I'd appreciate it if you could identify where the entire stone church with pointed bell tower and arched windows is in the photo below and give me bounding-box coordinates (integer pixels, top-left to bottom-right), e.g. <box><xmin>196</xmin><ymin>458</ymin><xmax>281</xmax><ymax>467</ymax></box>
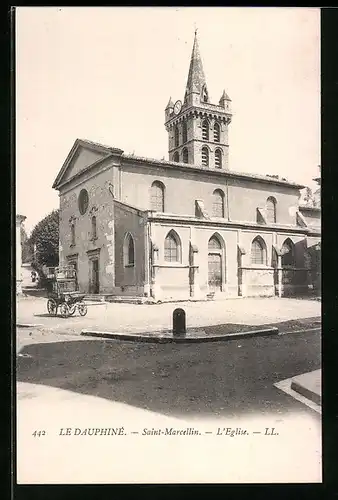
<box><xmin>53</xmin><ymin>35</ymin><xmax>320</xmax><ymax>301</ymax></box>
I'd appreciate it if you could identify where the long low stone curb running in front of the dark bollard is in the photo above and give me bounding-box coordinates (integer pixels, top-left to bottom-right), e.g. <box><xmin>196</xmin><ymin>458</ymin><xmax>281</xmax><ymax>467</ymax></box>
<box><xmin>81</xmin><ymin>327</ymin><xmax>278</xmax><ymax>344</ymax></box>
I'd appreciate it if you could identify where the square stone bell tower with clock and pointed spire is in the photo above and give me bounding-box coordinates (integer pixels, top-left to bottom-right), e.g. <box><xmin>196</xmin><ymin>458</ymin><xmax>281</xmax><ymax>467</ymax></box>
<box><xmin>165</xmin><ymin>30</ymin><xmax>232</xmax><ymax>170</ymax></box>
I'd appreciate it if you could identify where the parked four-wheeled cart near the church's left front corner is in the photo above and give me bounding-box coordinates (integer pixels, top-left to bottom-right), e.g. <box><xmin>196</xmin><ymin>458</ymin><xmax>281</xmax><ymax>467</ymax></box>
<box><xmin>47</xmin><ymin>266</ymin><xmax>87</xmax><ymax>318</ymax></box>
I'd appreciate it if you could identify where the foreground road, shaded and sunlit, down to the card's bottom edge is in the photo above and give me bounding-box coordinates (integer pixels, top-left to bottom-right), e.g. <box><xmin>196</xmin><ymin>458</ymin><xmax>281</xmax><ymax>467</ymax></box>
<box><xmin>17</xmin><ymin>330</ymin><xmax>321</xmax><ymax>484</ymax></box>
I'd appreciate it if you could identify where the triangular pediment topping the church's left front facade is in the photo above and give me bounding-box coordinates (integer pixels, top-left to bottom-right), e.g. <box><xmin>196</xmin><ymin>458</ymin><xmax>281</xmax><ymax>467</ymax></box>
<box><xmin>53</xmin><ymin>139</ymin><xmax>121</xmax><ymax>188</ymax></box>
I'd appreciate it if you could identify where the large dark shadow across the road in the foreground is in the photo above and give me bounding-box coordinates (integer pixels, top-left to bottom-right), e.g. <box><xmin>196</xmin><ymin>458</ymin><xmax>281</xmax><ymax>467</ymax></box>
<box><xmin>17</xmin><ymin>318</ymin><xmax>320</xmax><ymax>418</ymax></box>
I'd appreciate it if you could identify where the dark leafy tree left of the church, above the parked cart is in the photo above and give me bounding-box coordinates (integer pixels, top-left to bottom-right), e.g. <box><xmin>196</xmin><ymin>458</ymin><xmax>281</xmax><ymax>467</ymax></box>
<box><xmin>30</xmin><ymin>210</ymin><xmax>59</xmax><ymax>270</ymax></box>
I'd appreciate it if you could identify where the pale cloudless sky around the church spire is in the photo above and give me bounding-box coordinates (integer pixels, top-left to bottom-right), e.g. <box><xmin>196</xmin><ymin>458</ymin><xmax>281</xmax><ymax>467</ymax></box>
<box><xmin>16</xmin><ymin>7</ymin><xmax>320</xmax><ymax>233</ymax></box>
